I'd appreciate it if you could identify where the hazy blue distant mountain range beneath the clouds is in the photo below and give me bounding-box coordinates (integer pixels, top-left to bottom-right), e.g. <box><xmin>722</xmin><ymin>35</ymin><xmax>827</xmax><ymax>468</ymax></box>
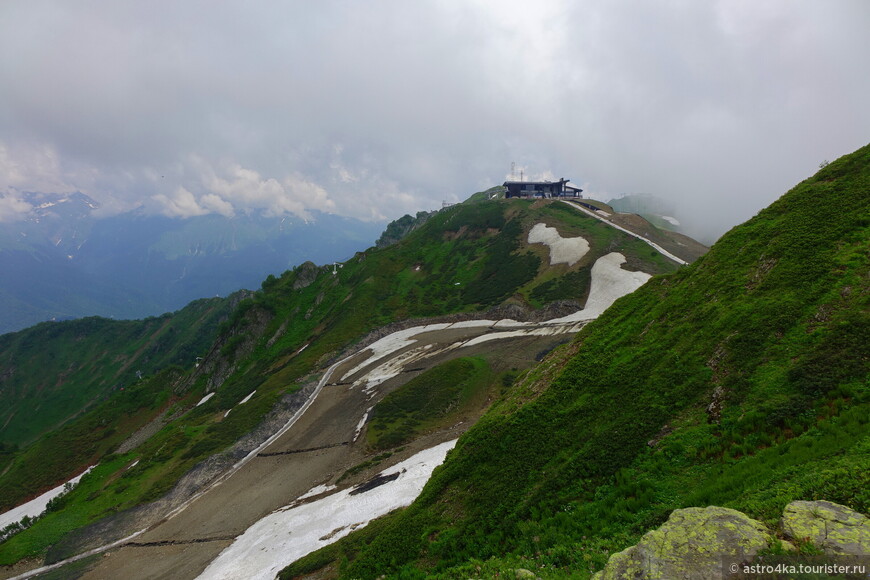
<box><xmin>0</xmin><ymin>192</ymin><xmax>384</xmax><ymax>334</ymax></box>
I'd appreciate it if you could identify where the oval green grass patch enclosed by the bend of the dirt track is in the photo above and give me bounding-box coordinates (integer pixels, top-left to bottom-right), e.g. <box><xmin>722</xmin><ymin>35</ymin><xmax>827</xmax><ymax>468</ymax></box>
<box><xmin>367</xmin><ymin>357</ymin><xmax>493</xmax><ymax>449</ymax></box>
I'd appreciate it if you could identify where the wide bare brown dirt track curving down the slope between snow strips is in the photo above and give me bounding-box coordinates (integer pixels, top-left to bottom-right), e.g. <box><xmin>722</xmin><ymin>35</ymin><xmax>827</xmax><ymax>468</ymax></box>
<box><xmin>49</xmin><ymin>324</ymin><xmax>579</xmax><ymax>580</ymax></box>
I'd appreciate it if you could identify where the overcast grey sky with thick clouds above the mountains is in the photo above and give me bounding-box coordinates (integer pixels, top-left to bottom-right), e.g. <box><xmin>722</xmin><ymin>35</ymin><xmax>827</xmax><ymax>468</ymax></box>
<box><xmin>0</xmin><ymin>0</ymin><xmax>870</xmax><ymax>240</ymax></box>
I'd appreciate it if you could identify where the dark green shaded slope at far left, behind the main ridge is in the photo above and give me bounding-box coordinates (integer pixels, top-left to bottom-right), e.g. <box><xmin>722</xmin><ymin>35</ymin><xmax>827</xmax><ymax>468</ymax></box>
<box><xmin>0</xmin><ymin>298</ymin><xmax>233</xmax><ymax>445</ymax></box>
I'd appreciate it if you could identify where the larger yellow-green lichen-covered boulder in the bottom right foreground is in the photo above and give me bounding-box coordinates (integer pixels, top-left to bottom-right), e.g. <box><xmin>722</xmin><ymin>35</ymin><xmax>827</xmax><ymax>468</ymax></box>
<box><xmin>593</xmin><ymin>506</ymin><xmax>772</xmax><ymax>580</ymax></box>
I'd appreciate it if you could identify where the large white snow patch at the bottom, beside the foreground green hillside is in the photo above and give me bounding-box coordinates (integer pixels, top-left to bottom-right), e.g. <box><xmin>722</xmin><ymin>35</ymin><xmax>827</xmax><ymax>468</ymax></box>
<box><xmin>199</xmin><ymin>440</ymin><xmax>456</xmax><ymax>580</ymax></box>
